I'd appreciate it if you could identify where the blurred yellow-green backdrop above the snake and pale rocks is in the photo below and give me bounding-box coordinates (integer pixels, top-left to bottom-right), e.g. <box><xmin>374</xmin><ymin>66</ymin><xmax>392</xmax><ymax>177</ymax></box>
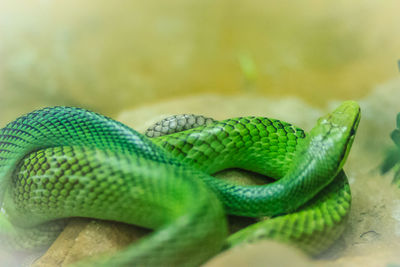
<box><xmin>0</xmin><ymin>0</ymin><xmax>400</xmax><ymax>126</ymax></box>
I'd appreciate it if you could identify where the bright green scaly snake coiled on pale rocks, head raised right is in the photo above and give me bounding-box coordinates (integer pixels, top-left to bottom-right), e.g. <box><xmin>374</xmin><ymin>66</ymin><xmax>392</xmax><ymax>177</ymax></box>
<box><xmin>0</xmin><ymin>101</ymin><xmax>360</xmax><ymax>266</ymax></box>
